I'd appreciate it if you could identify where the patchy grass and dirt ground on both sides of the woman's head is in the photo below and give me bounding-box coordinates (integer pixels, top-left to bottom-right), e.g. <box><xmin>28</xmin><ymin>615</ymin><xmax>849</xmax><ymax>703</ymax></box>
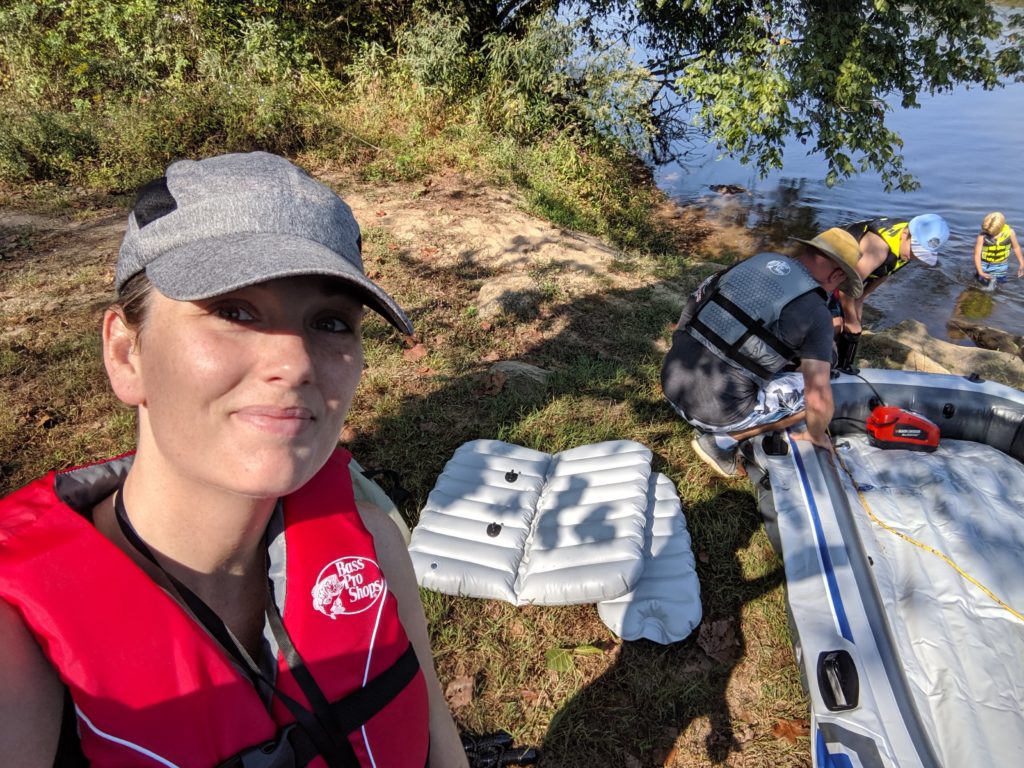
<box><xmin>0</xmin><ymin>177</ymin><xmax>809</xmax><ymax>766</ymax></box>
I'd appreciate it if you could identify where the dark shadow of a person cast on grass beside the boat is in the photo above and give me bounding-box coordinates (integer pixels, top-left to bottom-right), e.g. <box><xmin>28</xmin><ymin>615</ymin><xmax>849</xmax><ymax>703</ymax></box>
<box><xmin>542</xmin><ymin>490</ymin><xmax>782</xmax><ymax>766</ymax></box>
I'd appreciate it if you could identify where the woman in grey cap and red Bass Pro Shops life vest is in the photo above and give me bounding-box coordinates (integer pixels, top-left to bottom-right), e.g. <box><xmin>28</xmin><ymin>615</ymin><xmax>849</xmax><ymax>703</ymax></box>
<box><xmin>0</xmin><ymin>153</ymin><xmax>466</xmax><ymax>768</ymax></box>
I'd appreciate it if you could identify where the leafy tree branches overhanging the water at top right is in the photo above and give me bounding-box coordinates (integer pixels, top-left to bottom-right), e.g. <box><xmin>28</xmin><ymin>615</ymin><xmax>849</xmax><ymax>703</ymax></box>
<box><xmin>436</xmin><ymin>0</ymin><xmax>1024</xmax><ymax>189</ymax></box>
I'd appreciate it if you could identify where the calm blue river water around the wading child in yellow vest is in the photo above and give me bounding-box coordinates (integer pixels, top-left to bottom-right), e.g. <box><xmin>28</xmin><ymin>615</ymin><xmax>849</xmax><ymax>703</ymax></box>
<box><xmin>656</xmin><ymin>31</ymin><xmax>1024</xmax><ymax>343</ymax></box>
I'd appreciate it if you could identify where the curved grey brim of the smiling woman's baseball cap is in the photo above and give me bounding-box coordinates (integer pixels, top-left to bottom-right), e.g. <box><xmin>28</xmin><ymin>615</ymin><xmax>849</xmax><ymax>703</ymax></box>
<box><xmin>145</xmin><ymin>232</ymin><xmax>413</xmax><ymax>336</ymax></box>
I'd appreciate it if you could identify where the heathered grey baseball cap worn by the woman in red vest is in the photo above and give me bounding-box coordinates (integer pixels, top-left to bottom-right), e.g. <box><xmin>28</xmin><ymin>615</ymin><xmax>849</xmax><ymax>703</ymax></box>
<box><xmin>114</xmin><ymin>152</ymin><xmax>413</xmax><ymax>334</ymax></box>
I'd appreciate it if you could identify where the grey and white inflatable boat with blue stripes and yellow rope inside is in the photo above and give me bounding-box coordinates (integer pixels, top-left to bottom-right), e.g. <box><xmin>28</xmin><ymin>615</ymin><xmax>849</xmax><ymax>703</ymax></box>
<box><xmin>744</xmin><ymin>370</ymin><xmax>1024</xmax><ymax>768</ymax></box>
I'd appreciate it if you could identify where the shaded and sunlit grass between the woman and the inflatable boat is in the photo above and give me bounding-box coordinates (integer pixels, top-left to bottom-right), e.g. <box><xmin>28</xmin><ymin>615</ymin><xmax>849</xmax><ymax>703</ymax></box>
<box><xmin>339</xmin><ymin>245</ymin><xmax>809</xmax><ymax>767</ymax></box>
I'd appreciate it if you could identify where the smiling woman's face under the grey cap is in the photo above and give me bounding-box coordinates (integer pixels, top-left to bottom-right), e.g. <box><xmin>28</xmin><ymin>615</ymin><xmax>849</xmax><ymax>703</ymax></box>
<box><xmin>112</xmin><ymin>276</ymin><xmax>364</xmax><ymax>498</ymax></box>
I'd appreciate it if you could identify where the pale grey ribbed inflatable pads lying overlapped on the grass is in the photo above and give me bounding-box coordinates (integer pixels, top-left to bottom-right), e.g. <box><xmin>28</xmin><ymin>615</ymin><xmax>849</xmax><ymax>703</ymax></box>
<box><xmin>410</xmin><ymin>440</ymin><xmax>700</xmax><ymax>643</ymax></box>
